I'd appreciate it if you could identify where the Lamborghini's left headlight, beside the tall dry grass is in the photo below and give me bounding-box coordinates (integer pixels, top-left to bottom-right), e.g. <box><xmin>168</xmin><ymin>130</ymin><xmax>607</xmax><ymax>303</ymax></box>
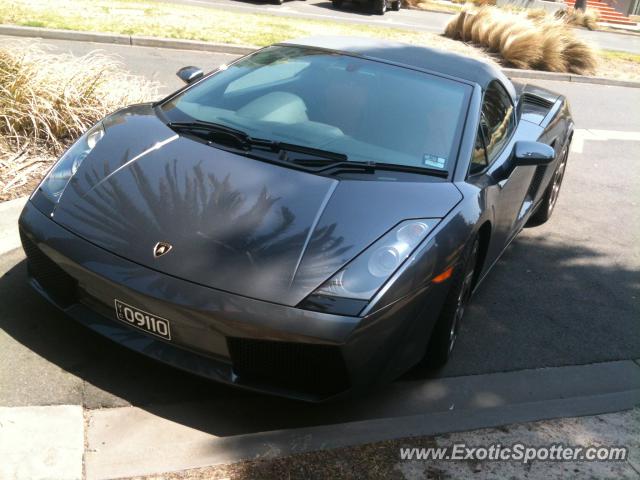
<box><xmin>40</xmin><ymin>122</ymin><xmax>104</xmax><ymax>203</ymax></box>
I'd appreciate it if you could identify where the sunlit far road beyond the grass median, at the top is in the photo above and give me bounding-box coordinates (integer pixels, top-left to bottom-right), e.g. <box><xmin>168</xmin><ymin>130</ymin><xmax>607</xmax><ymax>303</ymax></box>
<box><xmin>157</xmin><ymin>0</ymin><xmax>640</xmax><ymax>53</ymax></box>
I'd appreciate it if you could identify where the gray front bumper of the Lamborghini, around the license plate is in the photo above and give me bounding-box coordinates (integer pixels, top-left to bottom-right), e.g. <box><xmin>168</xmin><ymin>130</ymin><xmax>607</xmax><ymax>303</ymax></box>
<box><xmin>20</xmin><ymin>202</ymin><xmax>445</xmax><ymax>401</ymax></box>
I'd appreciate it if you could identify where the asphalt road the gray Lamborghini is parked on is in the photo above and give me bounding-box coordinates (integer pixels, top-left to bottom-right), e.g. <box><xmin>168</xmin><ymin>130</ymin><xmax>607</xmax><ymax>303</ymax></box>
<box><xmin>0</xmin><ymin>39</ymin><xmax>640</xmax><ymax>414</ymax></box>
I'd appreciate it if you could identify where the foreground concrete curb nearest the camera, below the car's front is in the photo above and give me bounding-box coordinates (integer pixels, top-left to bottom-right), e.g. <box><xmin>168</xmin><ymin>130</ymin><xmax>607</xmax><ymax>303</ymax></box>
<box><xmin>85</xmin><ymin>390</ymin><xmax>640</xmax><ymax>480</ymax></box>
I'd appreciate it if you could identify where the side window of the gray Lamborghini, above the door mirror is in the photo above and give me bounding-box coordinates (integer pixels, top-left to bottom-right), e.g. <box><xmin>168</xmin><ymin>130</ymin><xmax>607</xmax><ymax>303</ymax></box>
<box><xmin>482</xmin><ymin>82</ymin><xmax>515</xmax><ymax>163</ymax></box>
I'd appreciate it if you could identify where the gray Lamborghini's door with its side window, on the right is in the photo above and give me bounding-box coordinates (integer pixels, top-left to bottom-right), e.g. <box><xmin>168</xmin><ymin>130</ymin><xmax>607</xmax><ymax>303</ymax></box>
<box><xmin>468</xmin><ymin>81</ymin><xmax>535</xmax><ymax>259</ymax></box>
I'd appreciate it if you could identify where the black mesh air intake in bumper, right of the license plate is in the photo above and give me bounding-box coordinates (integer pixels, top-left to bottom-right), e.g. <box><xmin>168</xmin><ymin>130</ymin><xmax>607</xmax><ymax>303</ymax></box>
<box><xmin>227</xmin><ymin>338</ymin><xmax>349</xmax><ymax>395</ymax></box>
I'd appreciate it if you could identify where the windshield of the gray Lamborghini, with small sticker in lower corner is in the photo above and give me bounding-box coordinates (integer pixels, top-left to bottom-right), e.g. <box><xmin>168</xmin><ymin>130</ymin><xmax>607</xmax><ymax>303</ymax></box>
<box><xmin>161</xmin><ymin>46</ymin><xmax>471</xmax><ymax>171</ymax></box>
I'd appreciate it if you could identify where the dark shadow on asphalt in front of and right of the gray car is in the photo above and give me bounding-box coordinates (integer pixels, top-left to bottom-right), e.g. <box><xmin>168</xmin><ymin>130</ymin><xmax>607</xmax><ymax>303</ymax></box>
<box><xmin>0</xmin><ymin>232</ymin><xmax>640</xmax><ymax>436</ymax></box>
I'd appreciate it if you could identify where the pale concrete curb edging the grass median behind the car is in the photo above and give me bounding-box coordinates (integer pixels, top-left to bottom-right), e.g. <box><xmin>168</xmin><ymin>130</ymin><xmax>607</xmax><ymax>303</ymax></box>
<box><xmin>0</xmin><ymin>25</ymin><xmax>640</xmax><ymax>88</ymax></box>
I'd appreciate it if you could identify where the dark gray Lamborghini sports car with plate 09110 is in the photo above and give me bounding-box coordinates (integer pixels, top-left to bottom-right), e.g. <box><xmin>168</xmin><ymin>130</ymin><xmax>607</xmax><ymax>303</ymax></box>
<box><xmin>20</xmin><ymin>37</ymin><xmax>573</xmax><ymax>401</ymax></box>
